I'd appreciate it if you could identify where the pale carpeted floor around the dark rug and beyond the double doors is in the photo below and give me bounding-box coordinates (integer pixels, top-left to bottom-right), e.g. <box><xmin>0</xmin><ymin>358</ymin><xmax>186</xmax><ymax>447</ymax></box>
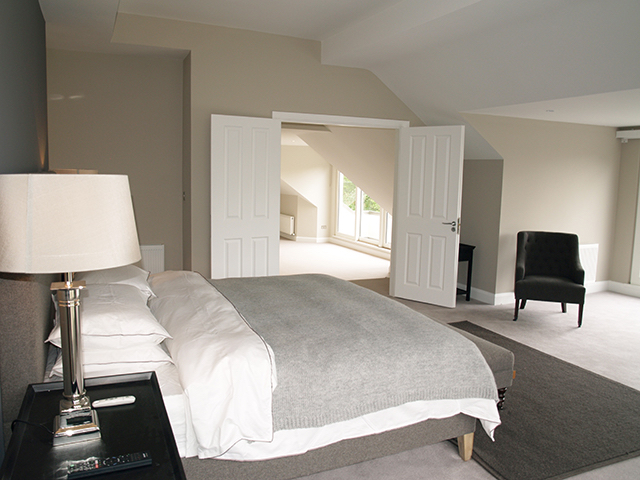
<box><xmin>281</xmin><ymin>241</ymin><xmax>640</xmax><ymax>480</ymax></box>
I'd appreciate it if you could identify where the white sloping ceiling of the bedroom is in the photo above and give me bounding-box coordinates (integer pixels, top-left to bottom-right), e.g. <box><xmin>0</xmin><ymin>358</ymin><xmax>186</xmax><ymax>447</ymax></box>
<box><xmin>40</xmin><ymin>0</ymin><xmax>640</xmax><ymax>158</ymax></box>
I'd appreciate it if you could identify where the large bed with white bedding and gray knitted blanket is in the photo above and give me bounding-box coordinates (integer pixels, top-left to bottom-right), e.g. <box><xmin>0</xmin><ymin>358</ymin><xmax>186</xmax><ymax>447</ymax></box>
<box><xmin>2</xmin><ymin>266</ymin><xmax>513</xmax><ymax>479</ymax></box>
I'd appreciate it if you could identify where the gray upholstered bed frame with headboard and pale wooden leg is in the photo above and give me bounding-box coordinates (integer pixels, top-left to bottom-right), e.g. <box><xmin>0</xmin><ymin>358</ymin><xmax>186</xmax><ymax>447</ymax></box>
<box><xmin>0</xmin><ymin>273</ymin><xmax>513</xmax><ymax>480</ymax></box>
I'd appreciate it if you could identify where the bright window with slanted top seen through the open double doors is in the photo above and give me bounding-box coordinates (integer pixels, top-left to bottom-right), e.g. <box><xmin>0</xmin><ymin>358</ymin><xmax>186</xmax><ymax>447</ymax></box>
<box><xmin>336</xmin><ymin>172</ymin><xmax>391</xmax><ymax>248</ymax></box>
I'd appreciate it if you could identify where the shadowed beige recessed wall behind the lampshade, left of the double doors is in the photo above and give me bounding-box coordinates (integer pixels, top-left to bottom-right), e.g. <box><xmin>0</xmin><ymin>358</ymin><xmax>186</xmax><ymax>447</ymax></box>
<box><xmin>47</xmin><ymin>50</ymin><xmax>182</xmax><ymax>269</ymax></box>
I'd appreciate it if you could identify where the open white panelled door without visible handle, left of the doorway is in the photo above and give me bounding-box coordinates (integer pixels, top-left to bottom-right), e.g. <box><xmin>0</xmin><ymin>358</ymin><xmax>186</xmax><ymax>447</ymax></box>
<box><xmin>211</xmin><ymin>115</ymin><xmax>280</xmax><ymax>278</ymax></box>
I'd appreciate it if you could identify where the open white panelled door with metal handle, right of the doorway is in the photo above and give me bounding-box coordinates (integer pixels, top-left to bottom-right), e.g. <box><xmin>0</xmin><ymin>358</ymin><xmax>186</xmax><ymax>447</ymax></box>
<box><xmin>390</xmin><ymin>126</ymin><xmax>464</xmax><ymax>307</ymax></box>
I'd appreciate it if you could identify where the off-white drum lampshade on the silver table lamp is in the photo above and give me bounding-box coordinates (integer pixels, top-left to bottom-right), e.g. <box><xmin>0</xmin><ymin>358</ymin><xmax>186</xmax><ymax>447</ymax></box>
<box><xmin>0</xmin><ymin>174</ymin><xmax>140</xmax><ymax>273</ymax></box>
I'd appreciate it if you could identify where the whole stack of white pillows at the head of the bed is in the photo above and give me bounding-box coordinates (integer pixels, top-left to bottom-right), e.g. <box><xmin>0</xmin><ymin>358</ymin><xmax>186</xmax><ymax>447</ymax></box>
<box><xmin>47</xmin><ymin>265</ymin><xmax>173</xmax><ymax>377</ymax></box>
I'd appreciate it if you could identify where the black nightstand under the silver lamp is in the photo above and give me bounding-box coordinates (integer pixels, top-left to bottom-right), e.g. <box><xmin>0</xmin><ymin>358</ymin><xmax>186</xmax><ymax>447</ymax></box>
<box><xmin>0</xmin><ymin>372</ymin><xmax>186</xmax><ymax>480</ymax></box>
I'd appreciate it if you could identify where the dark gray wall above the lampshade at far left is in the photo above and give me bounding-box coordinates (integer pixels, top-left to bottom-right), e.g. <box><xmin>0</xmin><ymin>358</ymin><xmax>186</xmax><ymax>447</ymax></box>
<box><xmin>0</xmin><ymin>0</ymin><xmax>48</xmax><ymax>173</ymax></box>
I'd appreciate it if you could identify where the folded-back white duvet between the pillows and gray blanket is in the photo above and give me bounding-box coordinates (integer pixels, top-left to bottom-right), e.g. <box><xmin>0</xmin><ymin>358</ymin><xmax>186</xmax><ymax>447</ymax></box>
<box><xmin>149</xmin><ymin>272</ymin><xmax>276</xmax><ymax>458</ymax></box>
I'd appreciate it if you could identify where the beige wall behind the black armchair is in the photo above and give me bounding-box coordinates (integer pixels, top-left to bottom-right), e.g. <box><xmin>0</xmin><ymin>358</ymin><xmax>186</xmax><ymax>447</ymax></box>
<box><xmin>465</xmin><ymin>115</ymin><xmax>620</xmax><ymax>293</ymax></box>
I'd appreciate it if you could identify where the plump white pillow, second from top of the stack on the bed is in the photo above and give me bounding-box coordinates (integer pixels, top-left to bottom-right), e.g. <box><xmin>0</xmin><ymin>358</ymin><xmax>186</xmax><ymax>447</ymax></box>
<box><xmin>47</xmin><ymin>284</ymin><xmax>171</xmax><ymax>349</ymax></box>
